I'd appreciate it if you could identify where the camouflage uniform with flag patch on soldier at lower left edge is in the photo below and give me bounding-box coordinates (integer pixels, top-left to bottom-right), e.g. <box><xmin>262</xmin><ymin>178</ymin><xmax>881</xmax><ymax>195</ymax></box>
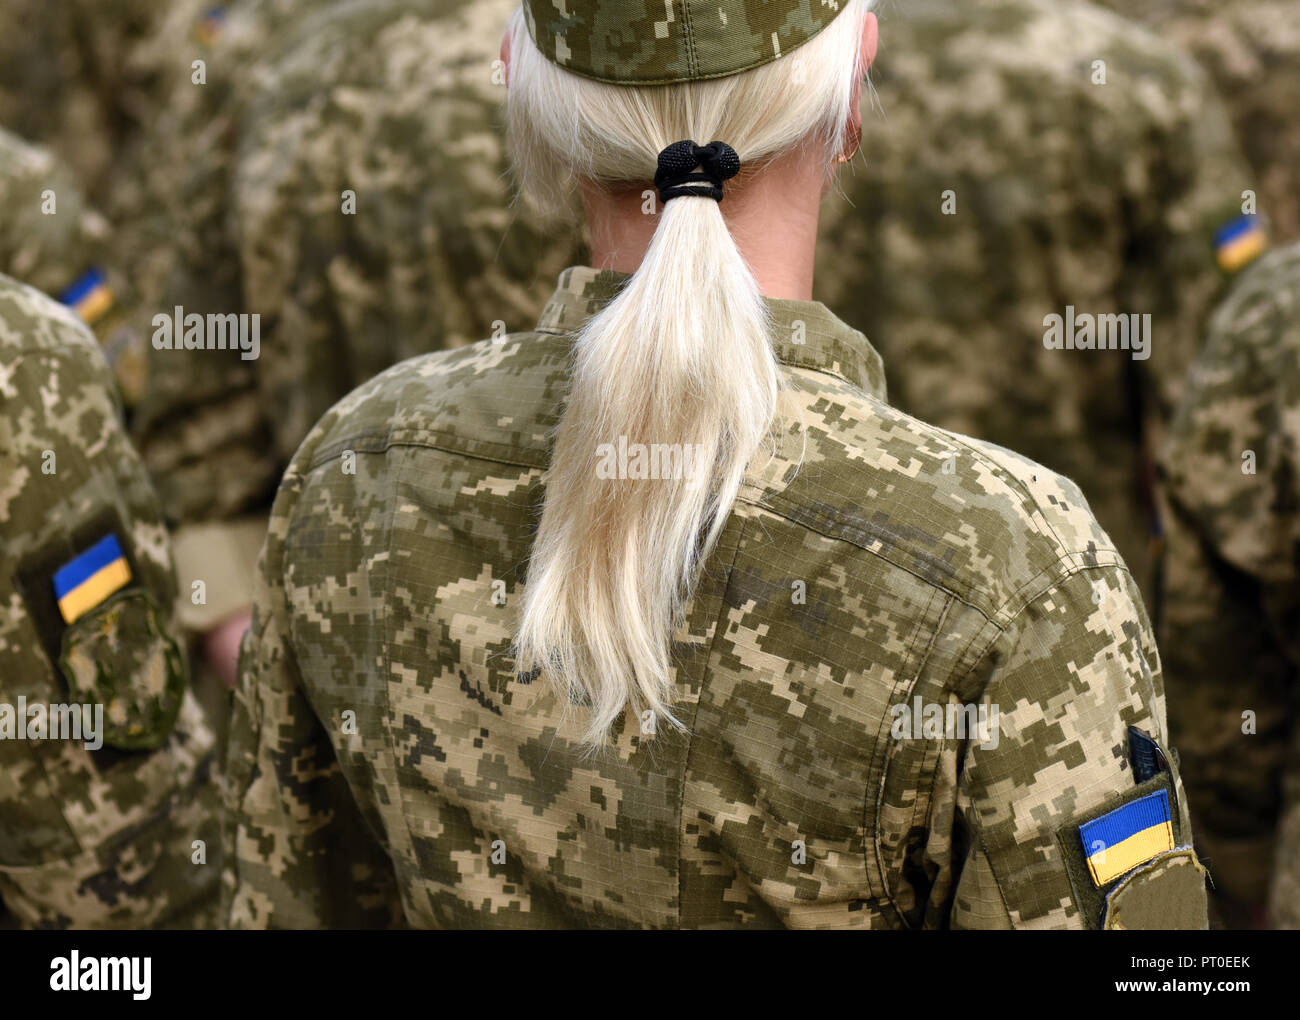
<box><xmin>0</xmin><ymin>277</ymin><xmax>220</xmax><ymax>928</ymax></box>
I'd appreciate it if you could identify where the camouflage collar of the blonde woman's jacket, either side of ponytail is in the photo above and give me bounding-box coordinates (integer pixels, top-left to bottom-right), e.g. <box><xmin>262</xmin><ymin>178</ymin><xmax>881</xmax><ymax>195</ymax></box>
<box><xmin>537</xmin><ymin>266</ymin><xmax>885</xmax><ymax>400</ymax></box>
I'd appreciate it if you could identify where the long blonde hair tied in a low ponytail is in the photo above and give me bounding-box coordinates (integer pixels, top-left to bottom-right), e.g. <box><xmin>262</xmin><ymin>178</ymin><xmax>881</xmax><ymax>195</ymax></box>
<box><xmin>507</xmin><ymin>0</ymin><xmax>871</xmax><ymax>746</ymax></box>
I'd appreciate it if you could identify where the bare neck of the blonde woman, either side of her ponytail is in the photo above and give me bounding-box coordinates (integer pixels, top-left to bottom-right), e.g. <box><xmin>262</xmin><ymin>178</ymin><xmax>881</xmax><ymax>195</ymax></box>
<box><xmin>582</xmin><ymin>147</ymin><xmax>824</xmax><ymax>301</ymax></box>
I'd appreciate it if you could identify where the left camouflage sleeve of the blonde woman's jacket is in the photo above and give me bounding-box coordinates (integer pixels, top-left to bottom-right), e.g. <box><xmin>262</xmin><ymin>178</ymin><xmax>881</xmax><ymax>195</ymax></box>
<box><xmin>226</xmin><ymin>470</ymin><xmax>402</xmax><ymax>929</ymax></box>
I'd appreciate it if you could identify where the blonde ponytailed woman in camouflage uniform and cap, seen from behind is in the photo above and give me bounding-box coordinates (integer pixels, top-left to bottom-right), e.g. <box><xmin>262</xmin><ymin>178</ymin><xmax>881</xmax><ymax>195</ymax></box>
<box><xmin>230</xmin><ymin>0</ymin><xmax>1205</xmax><ymax>928</ymax></box>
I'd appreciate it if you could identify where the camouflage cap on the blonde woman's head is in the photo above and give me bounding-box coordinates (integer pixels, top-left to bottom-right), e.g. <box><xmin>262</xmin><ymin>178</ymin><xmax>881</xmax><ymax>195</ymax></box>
<box><xmin>524</xmin><ymin>0</ymin><xmax>846</xmax><ymax>84</ymax></box>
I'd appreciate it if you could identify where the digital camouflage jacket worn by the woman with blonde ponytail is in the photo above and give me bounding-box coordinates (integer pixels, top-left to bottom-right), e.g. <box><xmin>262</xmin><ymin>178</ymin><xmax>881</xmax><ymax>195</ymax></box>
<box><xmin>229</xmin><ymin>268</ymin><xmax>1205</xmax><ymax>928</ymax></box>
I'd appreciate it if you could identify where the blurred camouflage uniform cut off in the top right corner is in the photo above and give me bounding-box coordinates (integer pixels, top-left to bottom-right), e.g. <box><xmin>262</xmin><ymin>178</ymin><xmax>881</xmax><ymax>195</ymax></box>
<box><xmin>1101</xmin><ymin>0</ymin><xmax>1300</xmax><ymax>240</ymax></box>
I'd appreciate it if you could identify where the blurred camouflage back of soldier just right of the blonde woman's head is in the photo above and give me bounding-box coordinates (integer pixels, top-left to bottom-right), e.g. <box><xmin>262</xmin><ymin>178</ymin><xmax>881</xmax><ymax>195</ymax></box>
<box><xmin>815</xmin><ymin>0</ymin><xmax>1255</xmax><ymax>603</ymax></box>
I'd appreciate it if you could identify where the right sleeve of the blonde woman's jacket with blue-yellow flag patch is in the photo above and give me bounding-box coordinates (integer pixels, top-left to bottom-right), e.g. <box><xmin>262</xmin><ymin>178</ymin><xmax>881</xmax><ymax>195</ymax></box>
<box><xmin>948</xmin><ymin>567</ymin><xmax>1206</xmax><ymax>928</ymax></box>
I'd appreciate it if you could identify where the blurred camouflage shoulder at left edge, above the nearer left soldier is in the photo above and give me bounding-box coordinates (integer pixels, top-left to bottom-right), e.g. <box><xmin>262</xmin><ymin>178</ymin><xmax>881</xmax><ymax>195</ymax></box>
<box><xmin>0</xmin><ymin>129</ymin><xmax>146</xmax><ymax>407</ymax></box>
